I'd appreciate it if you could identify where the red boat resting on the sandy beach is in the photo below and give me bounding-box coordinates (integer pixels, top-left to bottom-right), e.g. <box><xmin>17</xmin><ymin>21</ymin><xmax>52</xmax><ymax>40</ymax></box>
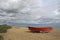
<box><xmin>28</xmin><ymin>26</ymin><xmax>53</xmax><ymax>32</ymax></box>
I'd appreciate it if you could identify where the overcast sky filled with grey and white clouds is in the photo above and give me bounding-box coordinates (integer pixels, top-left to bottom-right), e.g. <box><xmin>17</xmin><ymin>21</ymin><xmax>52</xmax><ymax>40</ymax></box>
<box><xmin>0</xmin><ymin>0</ymin><xmax>60</xmax><ymax>24</ymax></box>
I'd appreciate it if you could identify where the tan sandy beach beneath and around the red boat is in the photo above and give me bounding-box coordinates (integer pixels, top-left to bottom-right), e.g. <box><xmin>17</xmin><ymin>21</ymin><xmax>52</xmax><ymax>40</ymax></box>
<box><xmin>4</xmin><ymin>27</ymin><xmax>60</xmax><ymax>40</ymax></box>
